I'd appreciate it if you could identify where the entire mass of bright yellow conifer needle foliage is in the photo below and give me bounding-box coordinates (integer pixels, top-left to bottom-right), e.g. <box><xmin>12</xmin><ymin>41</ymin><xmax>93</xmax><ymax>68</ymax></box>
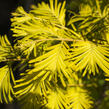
<box><xmin>0</xmin><ymin>0</ymin><xmax>109</xmax><ymax>109</ymax></box>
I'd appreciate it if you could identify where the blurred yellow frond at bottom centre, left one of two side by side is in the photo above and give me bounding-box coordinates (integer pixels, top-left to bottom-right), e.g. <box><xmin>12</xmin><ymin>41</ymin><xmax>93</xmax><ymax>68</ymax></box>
<box><xmin>45</xmin><ymin>88</ymin><xmax>69</xmax><ymax>109</ymax></box>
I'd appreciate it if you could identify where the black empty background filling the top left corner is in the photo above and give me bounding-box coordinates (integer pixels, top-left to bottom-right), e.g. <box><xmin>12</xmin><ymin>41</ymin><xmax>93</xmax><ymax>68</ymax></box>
<box><xmin>0</xmin><ymin>0</ymin><xmax>33</xmax><ymax>35</ymax></box>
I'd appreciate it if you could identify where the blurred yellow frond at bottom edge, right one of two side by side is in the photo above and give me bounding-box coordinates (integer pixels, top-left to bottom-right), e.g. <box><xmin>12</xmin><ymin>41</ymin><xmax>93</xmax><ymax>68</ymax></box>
<box><xmin>66</xmin><ymin>87</ymin><xmax>93</xmax><ymax>109</ymax></box>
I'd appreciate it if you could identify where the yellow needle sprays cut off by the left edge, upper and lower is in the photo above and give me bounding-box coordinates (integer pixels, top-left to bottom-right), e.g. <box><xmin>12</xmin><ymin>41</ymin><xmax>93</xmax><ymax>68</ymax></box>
<box><xmin>0</xmin><ymin>35</ymin><xmax>15</xmax><ymax>103</ymax></box>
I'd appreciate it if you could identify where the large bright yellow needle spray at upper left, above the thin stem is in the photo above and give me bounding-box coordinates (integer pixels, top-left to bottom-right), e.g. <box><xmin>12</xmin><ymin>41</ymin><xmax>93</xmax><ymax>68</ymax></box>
<box><xmin>11</xmin><ymin>0</ymin><xmax>68</xmax><ymax>39</ymax></box>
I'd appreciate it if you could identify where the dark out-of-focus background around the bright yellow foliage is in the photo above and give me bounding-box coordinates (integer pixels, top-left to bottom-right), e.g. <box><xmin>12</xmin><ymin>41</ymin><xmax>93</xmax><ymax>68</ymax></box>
<box><xmin>0</xmin><ymin>0</ymin><xmax>109</xmax><ymax>109</ymax></box>
